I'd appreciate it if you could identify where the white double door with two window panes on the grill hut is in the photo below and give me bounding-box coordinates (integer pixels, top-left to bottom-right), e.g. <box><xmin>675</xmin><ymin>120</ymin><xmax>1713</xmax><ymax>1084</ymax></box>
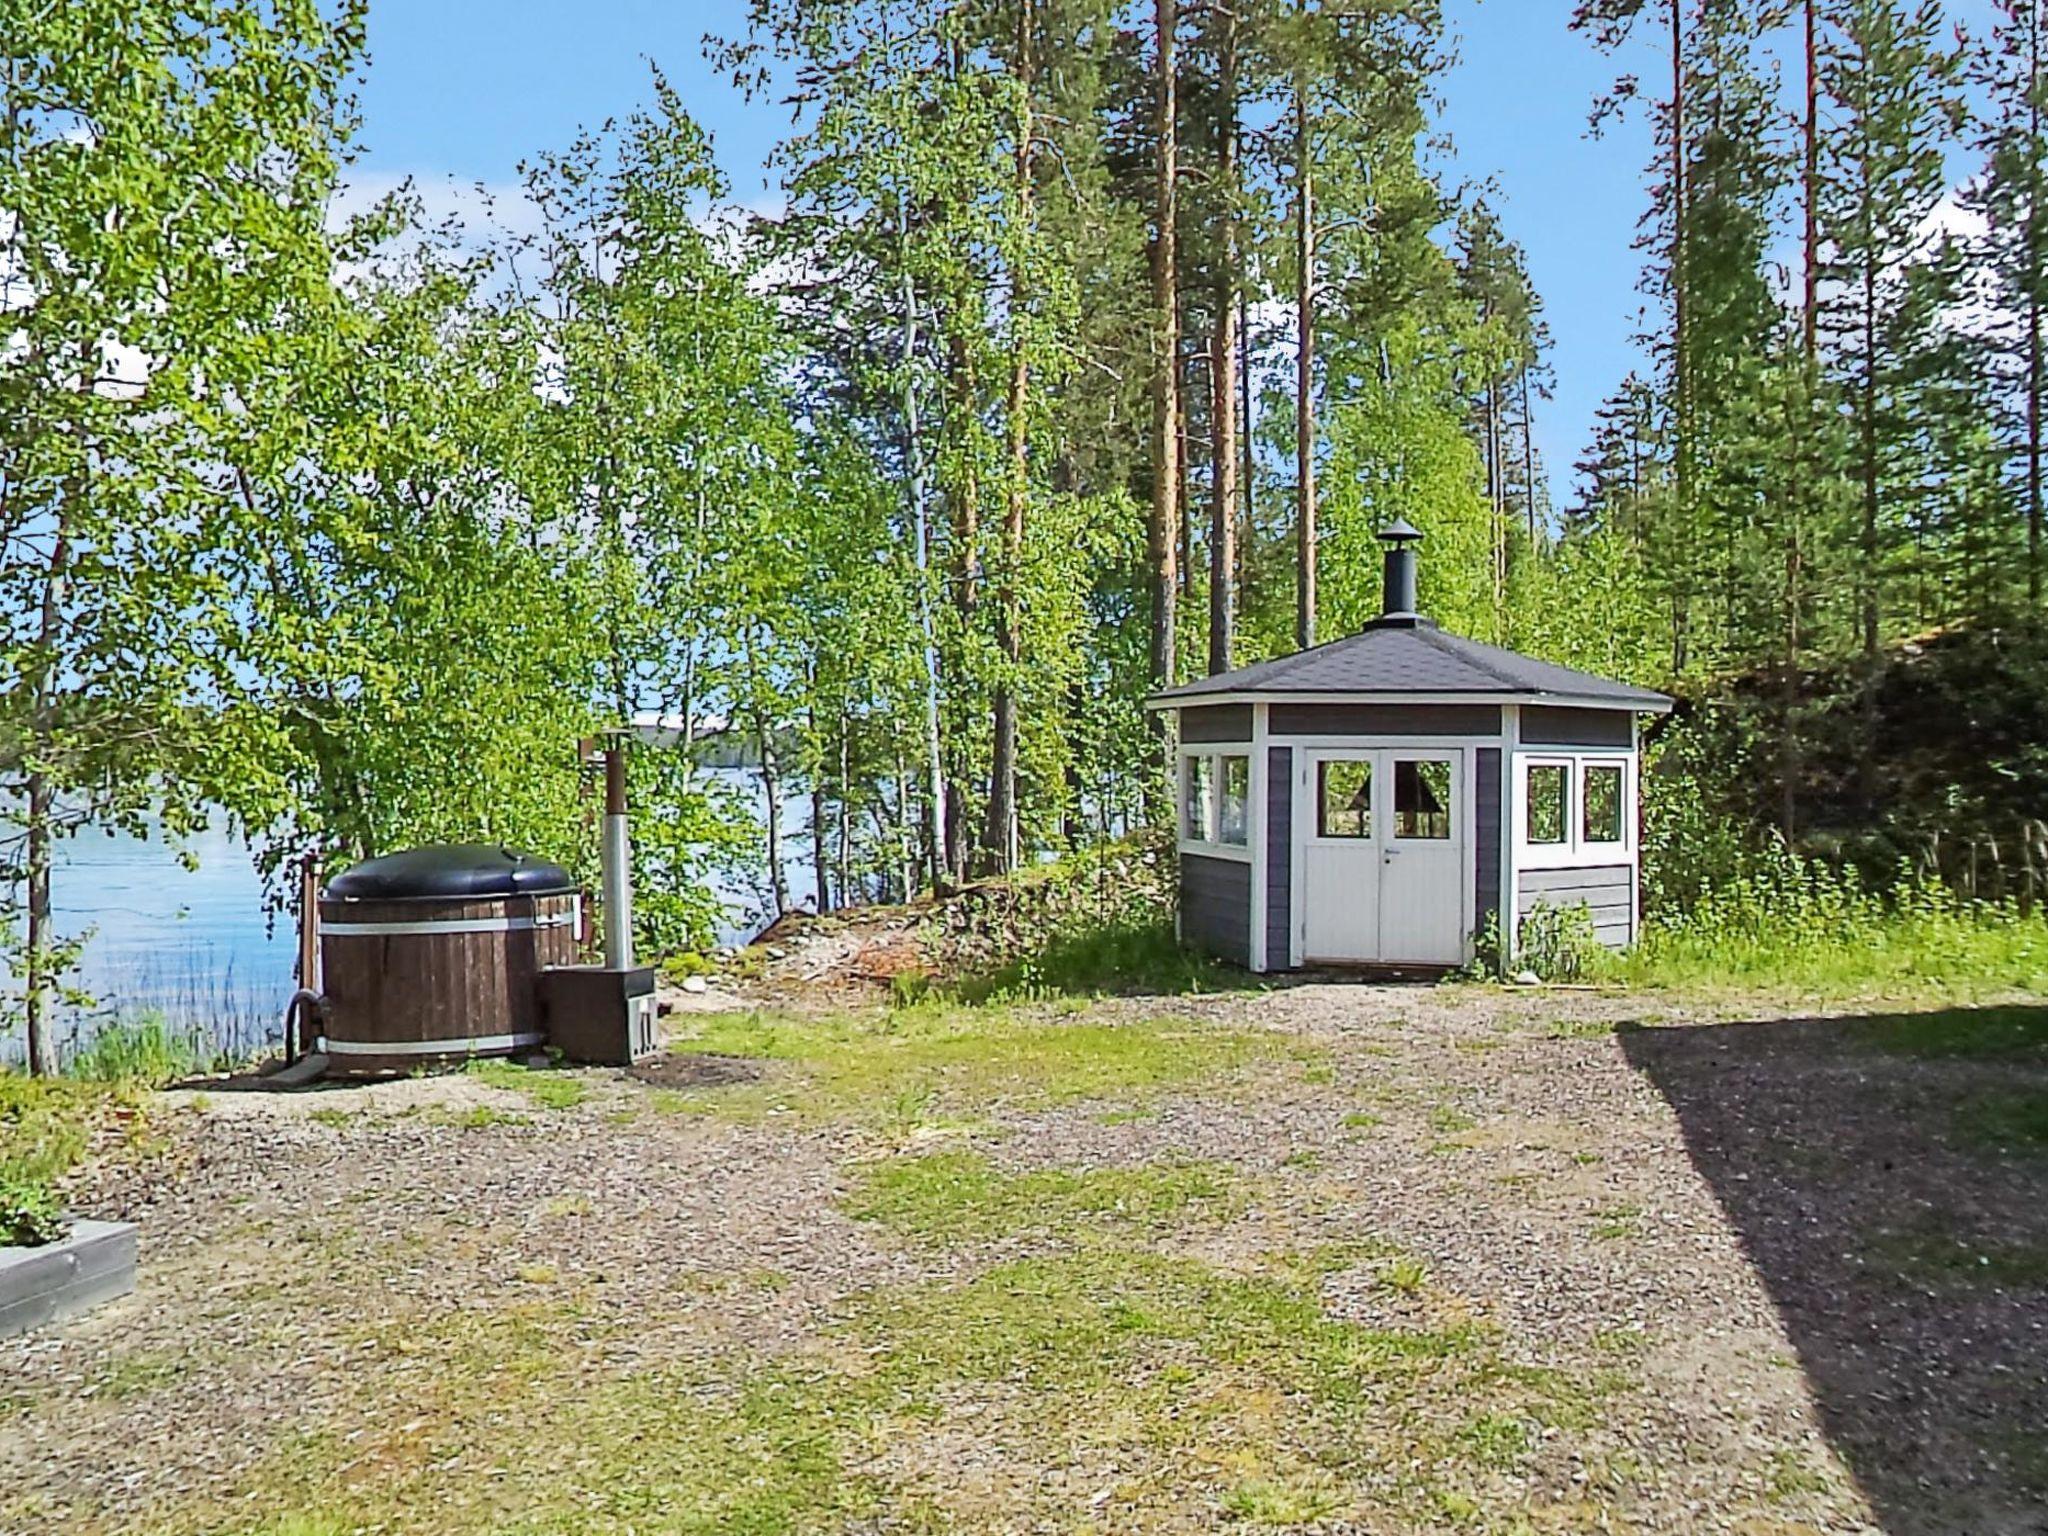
<box><xmin>1294</xmin><ymin>748</ymin><xmax>1468</xmax><ymax>965</ymax></box>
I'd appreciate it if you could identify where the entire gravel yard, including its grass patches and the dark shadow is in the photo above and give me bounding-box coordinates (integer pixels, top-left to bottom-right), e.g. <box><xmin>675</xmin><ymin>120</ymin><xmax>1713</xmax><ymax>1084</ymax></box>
<box><xmin>0</xmin><ymin>983</ymin><xmax>2048</xmax><ymax>1536</ymax></box>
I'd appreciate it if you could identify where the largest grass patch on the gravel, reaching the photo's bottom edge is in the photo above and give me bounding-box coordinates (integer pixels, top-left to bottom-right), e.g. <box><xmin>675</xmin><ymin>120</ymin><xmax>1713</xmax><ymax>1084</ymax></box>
<box><xmin>144</xmin><ymin>1241</ymin><xmax>1622</xmax><ymax>1536</ymax></box>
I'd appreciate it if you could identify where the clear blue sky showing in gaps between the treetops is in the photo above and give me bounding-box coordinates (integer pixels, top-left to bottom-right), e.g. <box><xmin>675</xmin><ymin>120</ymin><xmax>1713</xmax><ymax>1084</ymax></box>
<box><xmin>360</xmin><ymin>0</ymin><xmax>1649</xmax><ymax>496</ymax></box>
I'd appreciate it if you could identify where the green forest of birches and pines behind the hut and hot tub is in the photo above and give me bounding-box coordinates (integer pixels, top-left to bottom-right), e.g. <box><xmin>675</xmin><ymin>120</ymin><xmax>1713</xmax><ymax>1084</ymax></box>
<box><xmin>0</xmin><ymin>0</ymin><xmax>2048</xmax><ymax>1073</ymax></box>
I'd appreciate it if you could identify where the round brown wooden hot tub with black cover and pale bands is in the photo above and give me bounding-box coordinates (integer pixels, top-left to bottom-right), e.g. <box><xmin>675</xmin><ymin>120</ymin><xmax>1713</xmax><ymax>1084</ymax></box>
<box><xmin>319</xmin><ymin>844</ymin><xmax>580</xmax><ymax>1075</ymax></box>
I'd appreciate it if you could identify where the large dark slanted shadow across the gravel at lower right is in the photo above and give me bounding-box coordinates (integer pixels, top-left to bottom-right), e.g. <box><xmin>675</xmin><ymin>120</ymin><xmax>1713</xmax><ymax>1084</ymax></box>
<box><xmin>1620</xmin><ymin>1008</ymin><xmax>2048</xmax><ymax>1536</ymax></box>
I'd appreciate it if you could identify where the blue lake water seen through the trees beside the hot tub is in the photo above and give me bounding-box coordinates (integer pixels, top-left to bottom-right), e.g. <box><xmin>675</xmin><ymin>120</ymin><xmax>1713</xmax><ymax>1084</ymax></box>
<box><xmin>19</xmin><ymin>768</ymin><xmax>811</xmax><ymax>1061</ymax></box>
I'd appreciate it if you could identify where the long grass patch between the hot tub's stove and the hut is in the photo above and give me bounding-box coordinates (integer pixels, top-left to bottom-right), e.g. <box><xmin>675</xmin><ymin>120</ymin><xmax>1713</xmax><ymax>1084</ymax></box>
<box><xmin>657</xmin><ymin>1004</ymin><xmax>1298</xmax><ymax>1128</ymax></box>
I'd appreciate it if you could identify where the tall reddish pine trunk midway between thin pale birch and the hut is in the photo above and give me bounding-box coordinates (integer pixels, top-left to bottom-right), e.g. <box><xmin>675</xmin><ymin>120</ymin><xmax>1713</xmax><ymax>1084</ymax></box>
<box><xmin>987</xmin><ymin>0</ymin><xmax>1036</xmax><ymax>870</ymax></box>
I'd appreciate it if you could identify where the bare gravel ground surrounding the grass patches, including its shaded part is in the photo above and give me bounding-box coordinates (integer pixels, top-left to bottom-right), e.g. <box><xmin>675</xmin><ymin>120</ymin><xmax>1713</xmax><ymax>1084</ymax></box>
<box><xmin>0</xmin><ymin>983</ymin><xmax>2048</xmax><ymax>1536</ymax></box>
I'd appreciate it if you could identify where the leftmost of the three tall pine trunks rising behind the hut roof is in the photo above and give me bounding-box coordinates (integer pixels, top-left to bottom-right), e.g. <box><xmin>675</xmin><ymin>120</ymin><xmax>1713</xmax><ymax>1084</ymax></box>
<box><xmin>1145</xmin><ymin>0</ymin><xmax>1180</xmax><ymax>692</ymax></box>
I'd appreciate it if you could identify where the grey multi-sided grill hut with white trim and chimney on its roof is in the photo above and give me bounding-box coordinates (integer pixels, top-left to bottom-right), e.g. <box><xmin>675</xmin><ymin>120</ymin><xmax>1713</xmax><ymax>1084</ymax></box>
<box><xmin>1149</xmin><ymin>522</ymin><xmax>1671</xmax><ymax>971</ymax></box>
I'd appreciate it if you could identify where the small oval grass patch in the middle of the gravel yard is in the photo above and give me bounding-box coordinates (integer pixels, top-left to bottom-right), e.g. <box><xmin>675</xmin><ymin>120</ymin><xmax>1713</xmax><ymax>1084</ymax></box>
<box><xmin>842</xmin><ymin>1151</ymin><xmax>1243</xmax><ymax>1243</ymax></box>
